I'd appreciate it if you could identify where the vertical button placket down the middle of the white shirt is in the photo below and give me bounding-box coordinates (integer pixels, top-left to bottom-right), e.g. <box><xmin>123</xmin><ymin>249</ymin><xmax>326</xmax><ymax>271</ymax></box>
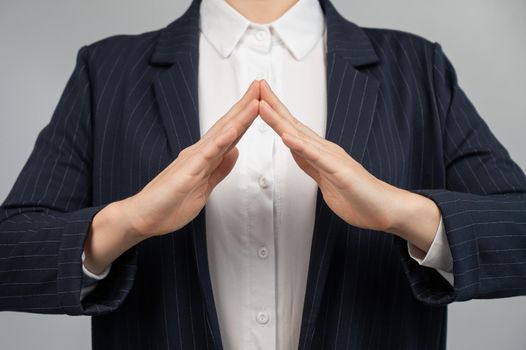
<box><xmin>247</xmin><ymin>22</ymin><xmax>276</xmax><ymax>348</ymax></box>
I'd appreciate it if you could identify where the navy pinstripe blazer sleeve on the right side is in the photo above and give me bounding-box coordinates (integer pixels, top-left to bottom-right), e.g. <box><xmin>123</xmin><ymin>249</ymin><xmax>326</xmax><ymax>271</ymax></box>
<box><xmin>399</xmin><ymin>43</ymin><xmax>526</xmax><ymax>305</ymax></box>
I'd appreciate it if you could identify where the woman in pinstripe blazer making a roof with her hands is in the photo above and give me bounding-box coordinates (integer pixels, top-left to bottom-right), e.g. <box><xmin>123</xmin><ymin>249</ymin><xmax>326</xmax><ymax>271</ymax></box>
<box><xmin>0</xmin><ymin>0</ymin><xmax>526</xmax><ymax>349</ymax></box>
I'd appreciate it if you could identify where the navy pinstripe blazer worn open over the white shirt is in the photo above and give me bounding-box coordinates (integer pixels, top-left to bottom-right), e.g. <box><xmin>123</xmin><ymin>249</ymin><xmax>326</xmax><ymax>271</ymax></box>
<box><xmin>0</xmin><ymin>0</ymin><xmax>526</xmax><ymax>349</ymax></box>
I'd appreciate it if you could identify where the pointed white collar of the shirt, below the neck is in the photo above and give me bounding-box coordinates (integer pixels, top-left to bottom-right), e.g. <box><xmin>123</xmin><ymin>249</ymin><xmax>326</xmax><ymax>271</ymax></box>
<box><xmin>200</xmin><ymin>0</ymin><xmax>325</xmax><ymax>60</ymax></box>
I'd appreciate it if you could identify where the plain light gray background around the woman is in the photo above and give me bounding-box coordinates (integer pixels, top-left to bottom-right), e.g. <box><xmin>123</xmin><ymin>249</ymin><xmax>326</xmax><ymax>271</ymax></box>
<box><xmin>0</xmin><ymin>0</ymin><xmax>526</xmax><ymax>350</ymax></box>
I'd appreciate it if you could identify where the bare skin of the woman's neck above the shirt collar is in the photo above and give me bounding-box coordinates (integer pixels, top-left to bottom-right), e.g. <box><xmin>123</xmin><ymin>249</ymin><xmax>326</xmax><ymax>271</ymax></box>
<box><xmin>225</xmin><ymin>0</ymin><xmax>299</xmax><ymax>24</ymax></box>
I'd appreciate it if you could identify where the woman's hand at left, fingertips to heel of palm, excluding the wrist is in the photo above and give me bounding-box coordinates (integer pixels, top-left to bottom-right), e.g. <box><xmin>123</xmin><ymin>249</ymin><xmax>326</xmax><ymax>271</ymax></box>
<box><xmin>121</xmin><ymin>81</ymin><xmax>259</xmax><ymax>237</ymax></box>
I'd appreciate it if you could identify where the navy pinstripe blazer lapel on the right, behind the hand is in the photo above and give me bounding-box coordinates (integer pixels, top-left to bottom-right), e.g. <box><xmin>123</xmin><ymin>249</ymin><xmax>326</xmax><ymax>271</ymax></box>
<box><xmin>299</xmin><ymin>0</ymin><xmax>379</xmax><ymax>350</ymax></box>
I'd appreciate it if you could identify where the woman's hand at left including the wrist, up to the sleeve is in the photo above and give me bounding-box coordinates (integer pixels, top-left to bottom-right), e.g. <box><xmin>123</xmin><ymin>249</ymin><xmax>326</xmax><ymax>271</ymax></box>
<box><xmin>84</xmin><ymin>81</ymin><xmax>260</xmax><ymax>274</ymax></box>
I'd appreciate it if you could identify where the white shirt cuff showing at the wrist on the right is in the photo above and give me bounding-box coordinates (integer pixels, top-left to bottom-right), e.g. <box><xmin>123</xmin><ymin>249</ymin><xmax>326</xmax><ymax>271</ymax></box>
<box><xmin>407</xmin><ymin>216</ymin><xmax>455</xmax><ymax>286</ymax></box>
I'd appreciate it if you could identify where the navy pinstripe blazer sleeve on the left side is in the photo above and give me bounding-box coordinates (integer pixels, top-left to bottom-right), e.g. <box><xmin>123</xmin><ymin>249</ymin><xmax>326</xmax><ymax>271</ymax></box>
<box><xmin>0</xmin><ymin>46</ymin><xmax>136</xmax><ymax>315</ymax></box>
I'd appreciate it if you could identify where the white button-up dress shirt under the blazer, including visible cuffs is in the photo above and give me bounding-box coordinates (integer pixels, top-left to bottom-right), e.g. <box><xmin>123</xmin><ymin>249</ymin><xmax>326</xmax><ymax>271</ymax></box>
<box><xmin>82</xmin><ymin>0</ymin><xmax>453</xmax><ymax>350</ymax></box>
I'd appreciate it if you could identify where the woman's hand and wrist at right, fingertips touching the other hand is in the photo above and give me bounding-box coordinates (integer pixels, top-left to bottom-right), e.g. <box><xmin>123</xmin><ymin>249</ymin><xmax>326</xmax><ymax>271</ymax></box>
<box><xmin>259</xmin><ymin>81</ymin><xmax>440</xmax><ymax>251</ymax></box>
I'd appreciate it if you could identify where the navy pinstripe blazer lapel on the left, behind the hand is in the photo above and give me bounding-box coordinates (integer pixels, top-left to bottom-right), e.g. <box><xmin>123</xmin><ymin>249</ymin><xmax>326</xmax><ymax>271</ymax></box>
<box><xmin>150</xmin><ymin>0</ymin><xmax>222</xmax><ymax>349</ymax></box>
